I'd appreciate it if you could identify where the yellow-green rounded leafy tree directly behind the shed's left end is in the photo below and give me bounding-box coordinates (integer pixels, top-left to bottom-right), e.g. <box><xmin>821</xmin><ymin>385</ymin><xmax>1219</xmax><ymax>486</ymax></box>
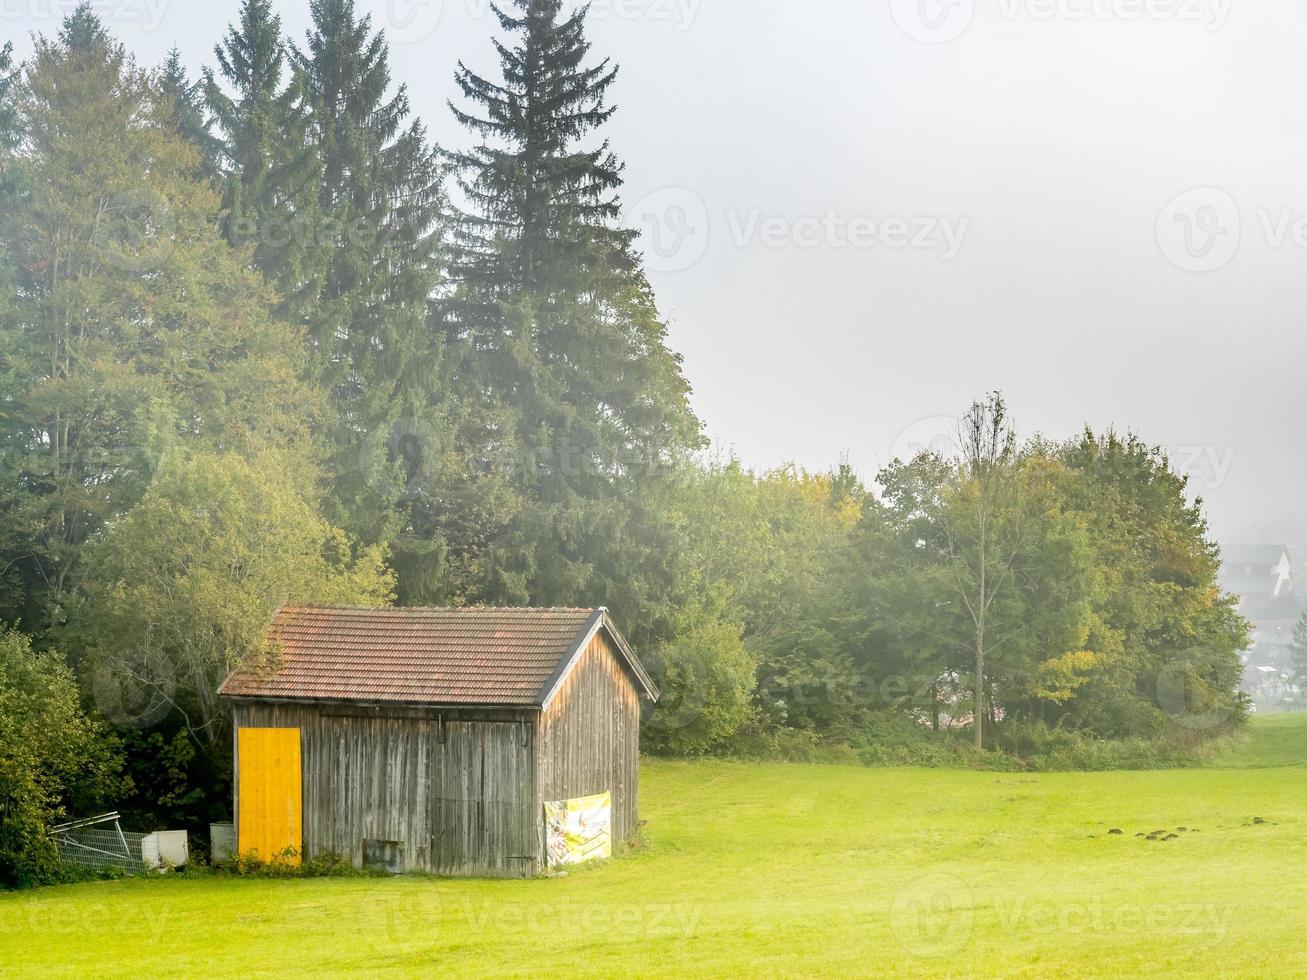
<box><xmin>68</xmin><ymin>453</ymin><xmax>393</xmax><ymax>751</ymax></box>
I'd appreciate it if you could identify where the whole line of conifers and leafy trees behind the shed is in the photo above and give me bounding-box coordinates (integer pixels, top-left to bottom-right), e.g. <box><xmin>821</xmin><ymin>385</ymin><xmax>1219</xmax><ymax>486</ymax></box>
<box><xmin>0</xmin><ymin>0</ymin><xmax>1247</xmax><ymax>882</ymax></box>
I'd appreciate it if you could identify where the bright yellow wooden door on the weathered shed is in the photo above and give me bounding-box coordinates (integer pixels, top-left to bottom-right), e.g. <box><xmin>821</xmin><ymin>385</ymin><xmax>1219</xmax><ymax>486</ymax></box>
<box><xmin>237</xmin><ymin>728</ymin><xmax>303</xmax><ymax>865</ymax></box>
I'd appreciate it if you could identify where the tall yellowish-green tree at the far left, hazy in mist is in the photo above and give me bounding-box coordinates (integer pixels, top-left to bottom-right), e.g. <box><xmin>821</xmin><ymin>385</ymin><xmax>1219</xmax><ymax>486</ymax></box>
<box><xmin>0</xmin><ymin>5</ymin><xmax>315</xmax><ymax>625</ymax></box>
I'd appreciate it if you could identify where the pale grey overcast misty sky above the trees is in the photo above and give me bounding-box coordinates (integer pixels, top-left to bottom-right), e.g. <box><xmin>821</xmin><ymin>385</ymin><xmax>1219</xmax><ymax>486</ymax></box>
<box><xmin>0</xmin><ymin>0</ymin><xmax>1307</xmax><ymax>542</ymax></box>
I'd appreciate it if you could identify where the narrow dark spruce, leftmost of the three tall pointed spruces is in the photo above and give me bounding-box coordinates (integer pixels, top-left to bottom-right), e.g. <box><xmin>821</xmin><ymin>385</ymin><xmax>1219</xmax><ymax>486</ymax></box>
<box><xmin>204</xmin><ymin>0</ymin><xmax>329</xmax><ymax>324</ymax></box>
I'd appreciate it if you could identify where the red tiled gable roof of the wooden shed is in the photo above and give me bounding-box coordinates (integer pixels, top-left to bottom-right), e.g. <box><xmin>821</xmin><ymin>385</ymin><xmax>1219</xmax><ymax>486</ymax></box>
<box><xmin>218</xmin><ymin>608</ymin><xmax>656</xmax><ymax>707</ymax></box>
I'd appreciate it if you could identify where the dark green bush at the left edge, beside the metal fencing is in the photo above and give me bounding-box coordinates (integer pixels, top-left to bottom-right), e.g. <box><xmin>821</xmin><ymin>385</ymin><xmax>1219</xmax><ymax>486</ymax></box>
<box><xmin>0</xmin><ymin>631</ymin><xmax>119</xmax><ymax>889</ymax></box>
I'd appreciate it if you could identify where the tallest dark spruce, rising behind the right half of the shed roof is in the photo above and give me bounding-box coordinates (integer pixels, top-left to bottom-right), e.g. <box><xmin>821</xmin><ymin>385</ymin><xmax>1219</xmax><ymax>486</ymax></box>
<box><xmin>437</xmin><ymin>0</ymin><xmax>699</xmax><ymax>618</ymax></box>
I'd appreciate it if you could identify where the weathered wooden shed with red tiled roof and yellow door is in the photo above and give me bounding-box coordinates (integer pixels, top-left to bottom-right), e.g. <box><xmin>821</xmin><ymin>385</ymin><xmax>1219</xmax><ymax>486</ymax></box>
<box><xmin>220</xmin><ymin>608</ymin><xmax>657</xmax><ymax>877</ymax></box>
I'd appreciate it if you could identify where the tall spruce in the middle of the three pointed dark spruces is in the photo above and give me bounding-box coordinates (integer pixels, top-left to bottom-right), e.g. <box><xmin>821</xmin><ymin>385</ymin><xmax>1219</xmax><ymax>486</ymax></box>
<box><xmin>290</xmin><ymin>0</ymin><xmax>444</xmax><ymax>541</ymax></box>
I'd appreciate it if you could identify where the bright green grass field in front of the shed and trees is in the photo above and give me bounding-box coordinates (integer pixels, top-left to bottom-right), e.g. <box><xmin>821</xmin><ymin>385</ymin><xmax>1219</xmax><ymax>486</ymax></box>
<box><xmin>0</xmin><ymin>716</ymin><xmax>1307</xmax><ymax>977</ymax></box>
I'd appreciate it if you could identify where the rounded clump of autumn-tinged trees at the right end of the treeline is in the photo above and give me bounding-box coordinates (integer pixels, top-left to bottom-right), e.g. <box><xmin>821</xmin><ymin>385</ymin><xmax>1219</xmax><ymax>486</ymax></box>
<box><xmin>857</xmin><ymin>420</ymin><xmax>1247</xmax><ymax>745</ymax></box>
